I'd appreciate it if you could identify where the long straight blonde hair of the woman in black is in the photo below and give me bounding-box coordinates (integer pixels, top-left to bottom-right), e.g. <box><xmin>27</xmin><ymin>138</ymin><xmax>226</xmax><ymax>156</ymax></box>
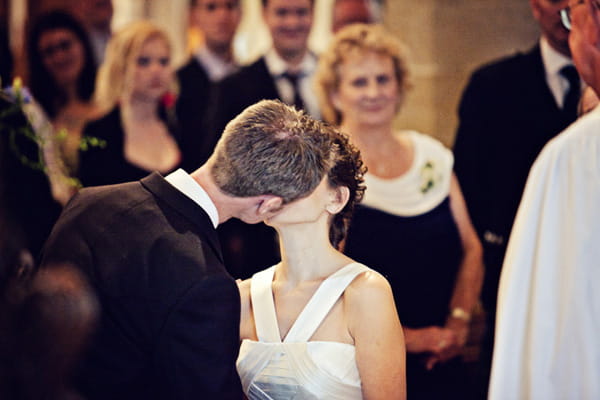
<box><xmin>94</xmin><ymin>21</ymin><xmax>171</xmax><ymax>112</ymax></box>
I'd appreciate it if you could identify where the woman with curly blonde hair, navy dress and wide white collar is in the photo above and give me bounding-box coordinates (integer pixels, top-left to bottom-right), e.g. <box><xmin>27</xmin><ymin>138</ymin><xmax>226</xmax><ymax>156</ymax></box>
<box><xmin>316</xmin><ymin>24</ymin><xmax>483</xmax><ymax>399</ymax></box>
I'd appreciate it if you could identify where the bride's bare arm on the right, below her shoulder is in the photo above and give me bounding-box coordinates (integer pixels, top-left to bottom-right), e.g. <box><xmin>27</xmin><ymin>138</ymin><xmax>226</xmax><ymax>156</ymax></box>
<box><xmin>345</xmin><ymin>271</ymin><xmax>406</xmax><ymax>400</ymax></box>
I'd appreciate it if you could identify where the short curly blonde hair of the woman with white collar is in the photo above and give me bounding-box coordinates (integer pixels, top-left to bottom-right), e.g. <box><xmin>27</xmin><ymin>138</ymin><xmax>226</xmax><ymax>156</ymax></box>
<box><xmin>315</xmin><ymin>24</ymin><xmax>410</xmax><ymax>125</ymax></box>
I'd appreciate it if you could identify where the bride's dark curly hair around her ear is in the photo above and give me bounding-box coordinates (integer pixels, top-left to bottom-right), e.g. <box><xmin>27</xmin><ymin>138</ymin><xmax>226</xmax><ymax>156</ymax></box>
<box><xmin>327</xmin><ymin>126</ymin><xmax>367</xmax><ymax>249</ymax></box>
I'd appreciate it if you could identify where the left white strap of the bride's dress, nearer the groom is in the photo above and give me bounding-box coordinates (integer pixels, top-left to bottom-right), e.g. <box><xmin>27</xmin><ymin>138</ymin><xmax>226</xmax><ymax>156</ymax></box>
<box><xmin>250</xmin><ymin>266</ymin><xmax>281</xmax><ymax>343</ymax></box>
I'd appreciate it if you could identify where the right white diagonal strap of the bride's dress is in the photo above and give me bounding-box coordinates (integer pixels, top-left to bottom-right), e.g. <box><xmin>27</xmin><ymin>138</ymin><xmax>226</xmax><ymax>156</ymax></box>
<box><xmin>284</xmin><ymin>263</ymin><xmax>369</xmax><ymax>343</ymax></box>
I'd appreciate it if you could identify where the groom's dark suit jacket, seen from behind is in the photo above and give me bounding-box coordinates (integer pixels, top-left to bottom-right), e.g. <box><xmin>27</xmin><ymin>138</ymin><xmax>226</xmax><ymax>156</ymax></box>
<box><xmin>43</xmin><ymin>173</ymin><xmax>241</xmax><ymax>400</ymax></box>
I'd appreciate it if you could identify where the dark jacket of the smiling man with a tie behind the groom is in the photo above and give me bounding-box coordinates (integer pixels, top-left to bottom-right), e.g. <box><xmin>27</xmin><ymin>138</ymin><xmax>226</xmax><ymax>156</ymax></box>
<box><xmin>209</xmin><ymin>57</ymin><xmax>280</xmax><ymax>279</ymax></box>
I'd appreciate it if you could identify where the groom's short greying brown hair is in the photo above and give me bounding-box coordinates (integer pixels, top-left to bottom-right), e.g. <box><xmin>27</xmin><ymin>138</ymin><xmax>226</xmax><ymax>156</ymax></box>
<box><xmin>211</xmin><ymin>100</ymin><xmax>340</xmax><ymax>204</ymax></box>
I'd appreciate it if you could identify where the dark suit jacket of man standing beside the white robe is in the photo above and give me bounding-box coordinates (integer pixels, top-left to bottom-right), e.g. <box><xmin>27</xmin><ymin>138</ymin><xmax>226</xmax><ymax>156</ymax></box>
<box><xmin>454</xmin><ymin>46</ymin><xmax>574</xmax><ymax>312</ymax></box>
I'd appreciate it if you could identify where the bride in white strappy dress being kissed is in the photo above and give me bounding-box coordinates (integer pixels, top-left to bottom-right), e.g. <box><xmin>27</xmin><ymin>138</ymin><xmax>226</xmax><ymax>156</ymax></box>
<box><xmin>237</xmin><ymin>124</ymin><xmax>406</xmax><ymax>400</ymax></box>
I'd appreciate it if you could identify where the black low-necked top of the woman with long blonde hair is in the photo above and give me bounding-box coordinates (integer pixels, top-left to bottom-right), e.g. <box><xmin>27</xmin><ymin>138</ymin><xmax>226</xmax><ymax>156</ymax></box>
<box><xmin>79</xmin><ymin>107</ymin><xmax>185</xmax><ymax>187</ymax></box>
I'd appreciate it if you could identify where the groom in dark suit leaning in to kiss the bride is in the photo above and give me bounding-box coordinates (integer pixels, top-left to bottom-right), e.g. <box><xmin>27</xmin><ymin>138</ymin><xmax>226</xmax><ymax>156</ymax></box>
<box><xmin>42</xmin><ymin>101</ymin><xmax>336</xmax><ymax>400</ymax></box>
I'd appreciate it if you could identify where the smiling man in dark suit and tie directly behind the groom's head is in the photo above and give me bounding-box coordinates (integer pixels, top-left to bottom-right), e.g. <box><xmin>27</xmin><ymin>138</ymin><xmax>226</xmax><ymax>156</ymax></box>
<box><xmin>209</xmin><ymin>0</ymin><xmax>320</xmax><ymax>278</ymax></box>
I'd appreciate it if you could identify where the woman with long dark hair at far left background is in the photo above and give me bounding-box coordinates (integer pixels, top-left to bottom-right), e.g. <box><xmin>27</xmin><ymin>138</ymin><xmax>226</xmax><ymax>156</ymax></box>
<box><xmin>28</xmin><ymin>11</ymin><xmax>97</xmax><ymax>204</ymax></box>
